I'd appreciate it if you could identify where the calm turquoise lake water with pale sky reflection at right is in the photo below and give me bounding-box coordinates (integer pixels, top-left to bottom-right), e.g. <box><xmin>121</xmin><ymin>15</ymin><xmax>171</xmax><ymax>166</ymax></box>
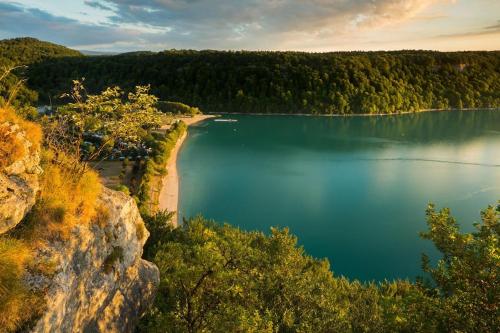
<box><xmin>178</xmin><ymin>111</ymin><xmax>500</xmax><ymax>281</ymax></box>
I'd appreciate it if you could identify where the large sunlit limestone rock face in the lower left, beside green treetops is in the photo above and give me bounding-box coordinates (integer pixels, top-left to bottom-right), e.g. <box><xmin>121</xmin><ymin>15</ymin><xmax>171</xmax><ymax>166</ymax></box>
<box><xmin>30</xmin><ymin>189</ymin><xmax>159</xmax><ymax>332</ymax></box>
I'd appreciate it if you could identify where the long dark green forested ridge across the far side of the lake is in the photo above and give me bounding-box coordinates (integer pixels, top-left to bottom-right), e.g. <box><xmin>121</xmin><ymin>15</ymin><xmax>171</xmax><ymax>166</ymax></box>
<box><xmin>0</xmin><ymin>38</ymin><xmax>500</xmax><ymax>114</ymax></box>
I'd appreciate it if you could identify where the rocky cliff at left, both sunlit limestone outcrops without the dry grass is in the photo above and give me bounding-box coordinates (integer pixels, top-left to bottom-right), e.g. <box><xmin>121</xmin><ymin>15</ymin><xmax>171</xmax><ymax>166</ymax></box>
<box><xmin>0</xmin><ymin>109</ymin><xmax>159</xmax><ymax>332</ymax></box>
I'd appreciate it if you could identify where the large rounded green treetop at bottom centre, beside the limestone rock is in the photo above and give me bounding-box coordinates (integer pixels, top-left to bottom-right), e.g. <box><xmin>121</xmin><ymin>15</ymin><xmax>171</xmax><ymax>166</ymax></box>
<box><xmin>144</xmin><ymin>217</ymin><xmax>350</xmax><ymax>332</ymax></box>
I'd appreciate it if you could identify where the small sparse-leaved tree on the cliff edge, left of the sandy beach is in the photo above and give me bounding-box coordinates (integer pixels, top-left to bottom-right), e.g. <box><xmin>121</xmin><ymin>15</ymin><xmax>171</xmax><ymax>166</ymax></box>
<box><xmin>44</xmin><ymin>80</ymin><xmax>163</xmax><ymax>174</ymax></box>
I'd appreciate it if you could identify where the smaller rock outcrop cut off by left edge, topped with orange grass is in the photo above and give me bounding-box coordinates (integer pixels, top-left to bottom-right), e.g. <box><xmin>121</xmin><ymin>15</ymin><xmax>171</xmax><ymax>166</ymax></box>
<box><xmin>0</xmin><ymin>123</ymin><xmax>41</xmax><ymax>234</ymax></box>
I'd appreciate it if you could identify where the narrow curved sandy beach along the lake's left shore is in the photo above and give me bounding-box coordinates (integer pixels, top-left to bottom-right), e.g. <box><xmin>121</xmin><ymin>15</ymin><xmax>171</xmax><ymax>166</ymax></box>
<box><xmin>158</xmin><ymin>115</ymin><xmax>215</xmax><ymax>226</ymax></box>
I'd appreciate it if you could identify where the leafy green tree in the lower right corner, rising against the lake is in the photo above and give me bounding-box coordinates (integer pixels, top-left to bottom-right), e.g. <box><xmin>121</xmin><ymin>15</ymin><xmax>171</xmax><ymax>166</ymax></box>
<box><xmin>422</xmin><ymin>205</ymin><xmax>500</xmax><ymax>332</ymax></box>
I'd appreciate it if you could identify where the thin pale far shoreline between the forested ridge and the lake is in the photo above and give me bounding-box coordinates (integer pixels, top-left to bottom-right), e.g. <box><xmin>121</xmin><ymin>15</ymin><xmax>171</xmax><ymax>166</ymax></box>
<box><xmin>207</xmin><ymin>107</ymin><xmax>500</xmax><ymax>118</ymax></box>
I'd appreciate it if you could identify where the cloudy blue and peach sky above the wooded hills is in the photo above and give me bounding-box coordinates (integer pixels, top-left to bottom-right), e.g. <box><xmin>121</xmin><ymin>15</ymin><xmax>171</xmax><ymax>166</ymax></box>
<box><xmin>0</xmin><ymin>0</ymin><xmax>500</xmax><ymax>52</ymax></box>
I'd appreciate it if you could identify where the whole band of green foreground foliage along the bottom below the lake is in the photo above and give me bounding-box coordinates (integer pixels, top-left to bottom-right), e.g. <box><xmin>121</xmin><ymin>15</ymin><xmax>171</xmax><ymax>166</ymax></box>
<box><xmin>140</xmin><ymin>206</ymin><xmax>500</xmax><ymax>332</ymax></box>
